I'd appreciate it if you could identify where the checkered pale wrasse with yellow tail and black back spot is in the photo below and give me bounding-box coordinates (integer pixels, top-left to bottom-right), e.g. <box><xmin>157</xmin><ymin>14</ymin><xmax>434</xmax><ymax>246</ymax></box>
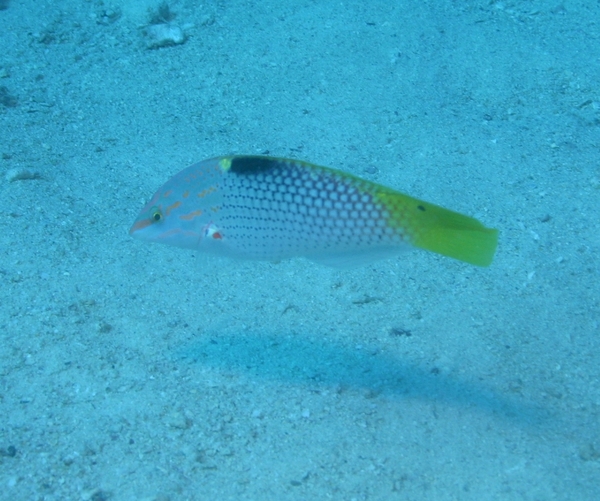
<box><xmin>129</xmin><ymin>155</ymin><xmax>498</xmax><ymax>268</ymax></box>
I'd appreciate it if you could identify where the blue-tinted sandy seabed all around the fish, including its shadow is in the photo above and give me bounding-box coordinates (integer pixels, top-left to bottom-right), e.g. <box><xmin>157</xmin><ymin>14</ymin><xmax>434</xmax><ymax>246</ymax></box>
<box><xmin>0</xmin><ymin>0</ymin><xmax>600</xmax><ymax>501</ymax></box>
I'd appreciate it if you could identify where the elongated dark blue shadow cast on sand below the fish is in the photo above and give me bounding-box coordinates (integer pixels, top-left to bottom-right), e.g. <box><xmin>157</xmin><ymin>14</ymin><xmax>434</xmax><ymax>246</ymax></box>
<box><xmin>175</xmin><ymin>333</ymin><xmax>551</xmax><ymax>427</ymax></box>
